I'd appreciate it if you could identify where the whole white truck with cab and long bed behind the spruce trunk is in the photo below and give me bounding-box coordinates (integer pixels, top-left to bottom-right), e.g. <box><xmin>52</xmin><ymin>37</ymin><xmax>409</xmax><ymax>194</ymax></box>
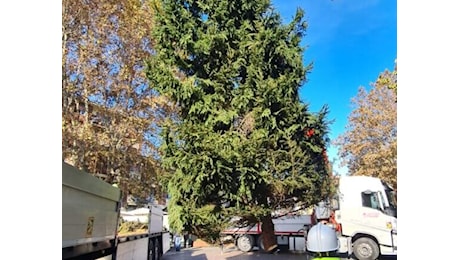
<box><xmin>222</xmin><ymin>176</ymin><xmax>397</xmax><ymax>260</ymax></box>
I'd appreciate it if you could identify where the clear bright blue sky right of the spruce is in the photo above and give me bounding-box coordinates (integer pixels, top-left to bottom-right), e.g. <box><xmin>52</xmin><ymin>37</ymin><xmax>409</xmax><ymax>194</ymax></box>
<box><xmin>272</xmin><ymin>0</ymin><xmax>397</xmax><ymax>174</ymax></box>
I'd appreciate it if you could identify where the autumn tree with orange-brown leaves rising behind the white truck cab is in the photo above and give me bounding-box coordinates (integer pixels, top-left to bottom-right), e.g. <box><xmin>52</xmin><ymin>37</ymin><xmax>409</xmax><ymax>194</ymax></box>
<box><xmin>334</xmin><ymin>63</ymin><xmax>397</xmax><ymax>188</ymax></box>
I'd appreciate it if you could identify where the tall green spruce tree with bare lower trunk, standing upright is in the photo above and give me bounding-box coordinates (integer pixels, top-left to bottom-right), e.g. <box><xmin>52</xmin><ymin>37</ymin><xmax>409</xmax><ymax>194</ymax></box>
<box><xmin>147</xmin><ymin>0</ymin><xmax>330</xmax><ymax>251</ymax></box>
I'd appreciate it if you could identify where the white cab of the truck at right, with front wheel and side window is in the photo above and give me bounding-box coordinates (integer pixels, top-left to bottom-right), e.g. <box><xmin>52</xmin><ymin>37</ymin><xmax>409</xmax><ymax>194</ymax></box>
<box><xmin>333</xmin><ymin>176</ymin><xmax>397</xmax><ymax>260</ymax></box>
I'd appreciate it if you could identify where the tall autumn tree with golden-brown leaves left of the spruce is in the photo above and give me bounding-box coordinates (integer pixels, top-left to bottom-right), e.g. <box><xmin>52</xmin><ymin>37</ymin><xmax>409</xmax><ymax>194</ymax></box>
<box><xmin>62</xmin><ymin>0</ymin><xmax>173</xmax><ymax>205</ymax></box>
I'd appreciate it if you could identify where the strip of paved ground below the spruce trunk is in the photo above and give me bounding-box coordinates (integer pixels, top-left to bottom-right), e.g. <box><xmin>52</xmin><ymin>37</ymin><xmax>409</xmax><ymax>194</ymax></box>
<box><xmin>162</xmin><ymin>247</ymin><xmax>397</xmax><ymax>260</ymax></box>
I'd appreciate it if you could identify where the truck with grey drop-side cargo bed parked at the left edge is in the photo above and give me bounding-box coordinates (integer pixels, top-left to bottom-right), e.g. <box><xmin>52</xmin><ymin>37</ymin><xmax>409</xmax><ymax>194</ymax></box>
<box><xmin>62</xmin><ymin>162</ymin><xmax>170</xmax><ymax>260</ymax></box>
